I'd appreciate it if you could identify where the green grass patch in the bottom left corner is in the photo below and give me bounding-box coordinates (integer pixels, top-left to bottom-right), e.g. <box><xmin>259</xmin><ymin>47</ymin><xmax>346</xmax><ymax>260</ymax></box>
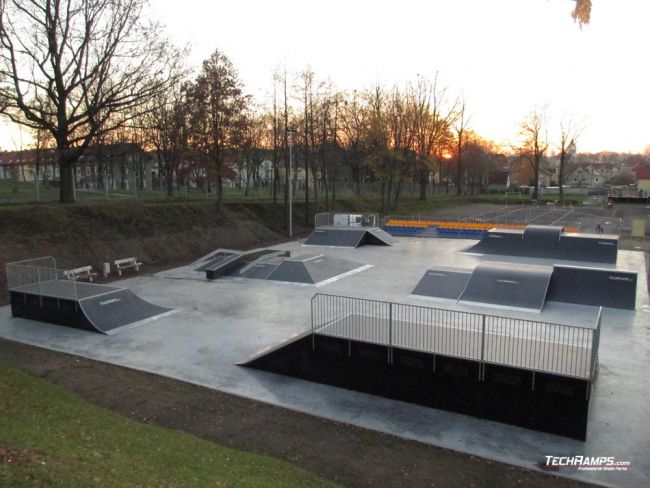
<box><xmin>0</xmin><ymin>368</ymin><xmax>333</xmax><ymax>487</ymax></box>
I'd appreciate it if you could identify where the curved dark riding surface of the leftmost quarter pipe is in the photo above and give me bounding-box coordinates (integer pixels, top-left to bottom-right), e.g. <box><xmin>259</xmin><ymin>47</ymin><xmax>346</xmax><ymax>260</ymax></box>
<box><xmin>79</xmin><ymin>289</ymin><xmax>173</xmax><ymax>333</ymax></box>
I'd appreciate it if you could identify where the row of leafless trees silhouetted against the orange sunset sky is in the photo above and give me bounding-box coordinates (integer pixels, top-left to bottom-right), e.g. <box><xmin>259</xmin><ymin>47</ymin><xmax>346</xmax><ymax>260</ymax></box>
<box><xmin>0</xmin><ymin>0</ymin><xmax>578</xmax><ymax>214</ymax></box>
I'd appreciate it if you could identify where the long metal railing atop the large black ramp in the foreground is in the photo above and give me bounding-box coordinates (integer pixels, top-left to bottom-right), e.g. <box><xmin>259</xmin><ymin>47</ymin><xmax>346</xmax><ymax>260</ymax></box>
<box><xmin>311</xmin><ymin>293</ymin><xmax>601</xmax><ymax>380</ymax></box>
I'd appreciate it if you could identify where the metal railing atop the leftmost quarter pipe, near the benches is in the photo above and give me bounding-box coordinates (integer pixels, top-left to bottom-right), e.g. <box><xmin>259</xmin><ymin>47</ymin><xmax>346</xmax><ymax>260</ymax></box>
<box><xmin>5</xmin><ymin>256</ymin><xmax>79</xmax><ymax>300</ymax></box>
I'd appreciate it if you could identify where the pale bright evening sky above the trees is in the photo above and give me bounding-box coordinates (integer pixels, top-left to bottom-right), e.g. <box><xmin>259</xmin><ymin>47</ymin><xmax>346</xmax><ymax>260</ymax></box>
<box><xmin>0</xmin><ymin>0</ymin><xmax>650</xmax><ymax>152</ymax></box>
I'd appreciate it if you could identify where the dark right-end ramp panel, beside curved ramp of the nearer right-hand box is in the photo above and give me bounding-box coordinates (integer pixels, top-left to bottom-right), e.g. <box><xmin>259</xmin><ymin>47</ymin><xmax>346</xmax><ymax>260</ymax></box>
<box><xmin>546</xmin><ymin>266</ymin><xmax>637</xmax><ymax>310</ymax></box>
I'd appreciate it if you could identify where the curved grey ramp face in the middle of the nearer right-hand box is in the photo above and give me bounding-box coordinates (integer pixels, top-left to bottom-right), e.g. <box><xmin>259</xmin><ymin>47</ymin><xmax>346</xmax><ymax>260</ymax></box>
<box><xmin>461</xmin><ymin>263</ymin><xmax>553</xmax><ymax>311</ymax></box>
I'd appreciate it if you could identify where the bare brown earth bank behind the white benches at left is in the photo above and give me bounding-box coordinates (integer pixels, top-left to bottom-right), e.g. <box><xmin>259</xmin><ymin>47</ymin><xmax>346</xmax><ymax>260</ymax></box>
<box><xmin>0</xmin><ymin>203</ymin><xmax>285</xmax><ymax>304</ymax></box>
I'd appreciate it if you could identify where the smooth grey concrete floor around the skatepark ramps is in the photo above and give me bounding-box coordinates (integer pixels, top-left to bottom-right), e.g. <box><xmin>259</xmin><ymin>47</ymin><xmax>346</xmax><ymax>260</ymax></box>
<box><xmin>0</xmin><ymin>234</ymin><xmax>650</xmax><ymax>486</ymax></box>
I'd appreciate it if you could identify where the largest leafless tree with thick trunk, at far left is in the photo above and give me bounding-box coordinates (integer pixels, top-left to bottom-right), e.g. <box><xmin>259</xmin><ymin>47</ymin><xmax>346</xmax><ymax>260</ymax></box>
<box><xmin>0</xmin><ymin>0</ymin><xmax>181</xmax><ymax>203</ymax></box>
